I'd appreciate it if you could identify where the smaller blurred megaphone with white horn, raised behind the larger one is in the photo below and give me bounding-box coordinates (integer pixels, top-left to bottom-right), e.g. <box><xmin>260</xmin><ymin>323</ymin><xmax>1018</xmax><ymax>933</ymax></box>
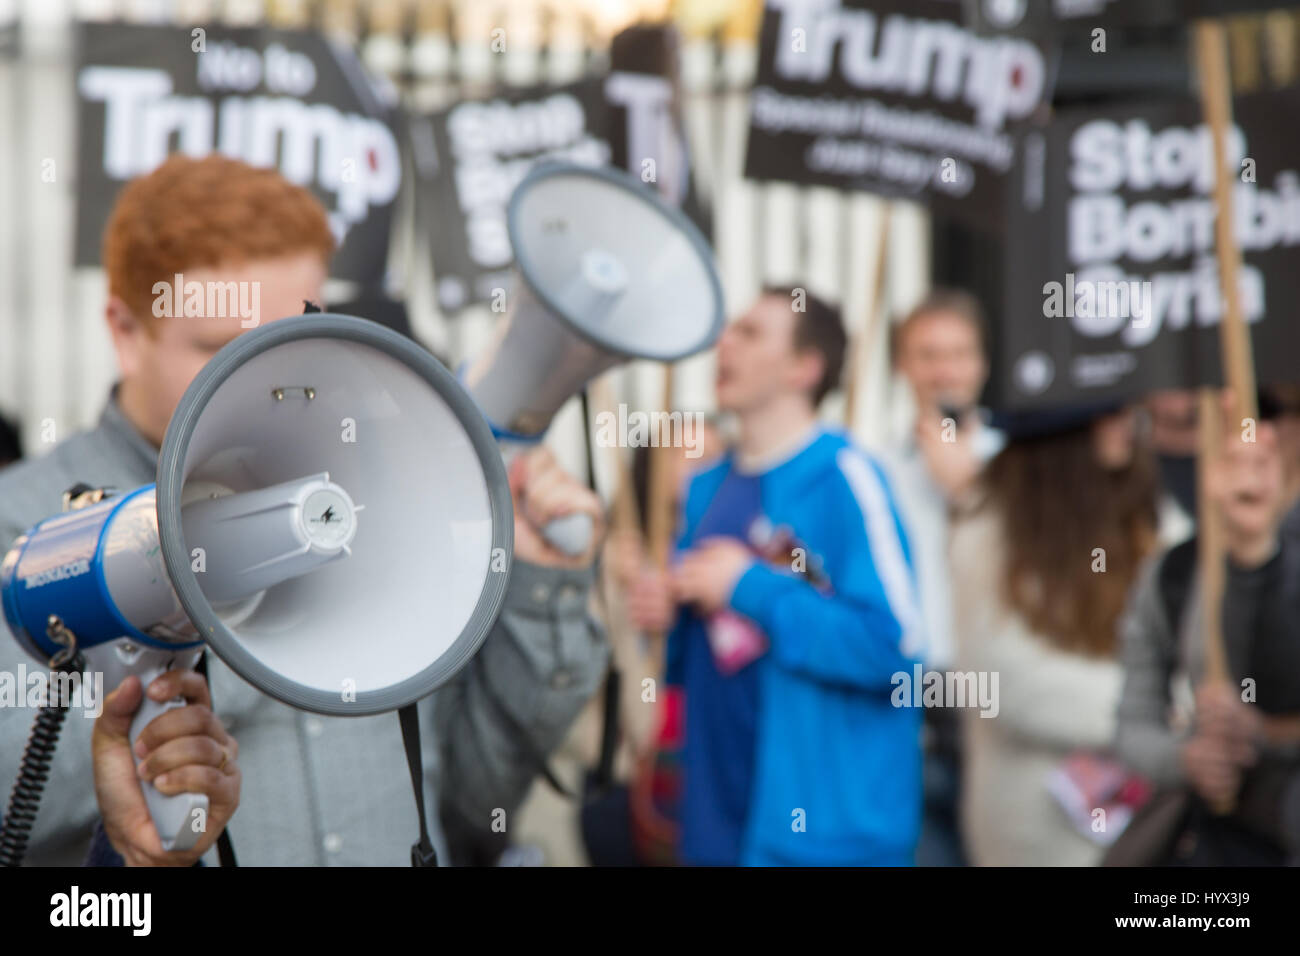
<box><xmin>463</xmin><ymin>163</ymin><xmax>723</xmax><ymax>555</ymax></box>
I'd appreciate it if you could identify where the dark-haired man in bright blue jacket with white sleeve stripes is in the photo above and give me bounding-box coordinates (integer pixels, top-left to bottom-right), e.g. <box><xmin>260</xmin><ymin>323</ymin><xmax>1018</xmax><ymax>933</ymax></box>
<box><xmin>638</xmin><ymin>290</ymin><xmax>924</xmax><ymax>865</ymax></box>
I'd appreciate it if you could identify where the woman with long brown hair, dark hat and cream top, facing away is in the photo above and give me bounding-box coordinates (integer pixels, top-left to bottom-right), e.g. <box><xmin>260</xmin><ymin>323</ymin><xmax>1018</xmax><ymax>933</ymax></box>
<box><xmin>952</xmin><ymin>408</ymin><xmax>1156</xmax><ymax>866</ymax></box>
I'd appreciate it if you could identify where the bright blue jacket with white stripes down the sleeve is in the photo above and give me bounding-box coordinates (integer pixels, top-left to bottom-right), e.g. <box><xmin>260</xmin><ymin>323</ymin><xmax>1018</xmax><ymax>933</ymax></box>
<box><xmin>668</xmin><ymin>429</ymin><xmax>924</xmax><ymax>865</ymax></box>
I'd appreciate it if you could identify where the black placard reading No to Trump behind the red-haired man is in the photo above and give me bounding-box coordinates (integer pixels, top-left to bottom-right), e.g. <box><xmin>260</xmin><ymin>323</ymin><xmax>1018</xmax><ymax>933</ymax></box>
<box><xmin>75</xmin><ymin>23</ymin><xmax>402</xmax><ymax>284</ymax></box>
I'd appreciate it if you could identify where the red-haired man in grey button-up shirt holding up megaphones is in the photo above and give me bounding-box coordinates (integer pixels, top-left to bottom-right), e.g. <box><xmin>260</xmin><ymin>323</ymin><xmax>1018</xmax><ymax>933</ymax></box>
<box><xmin>0</xmin><ymin>155</ymin><xmax>608</xmax><ymax>866</ymax></box>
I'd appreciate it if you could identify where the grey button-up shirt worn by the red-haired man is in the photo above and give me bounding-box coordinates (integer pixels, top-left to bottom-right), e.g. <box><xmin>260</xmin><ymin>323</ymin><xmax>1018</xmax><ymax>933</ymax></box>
<box><xmin>0</xmin><ymin>397</ymin><xmax>608</xmax><ymax>866</ymax></box>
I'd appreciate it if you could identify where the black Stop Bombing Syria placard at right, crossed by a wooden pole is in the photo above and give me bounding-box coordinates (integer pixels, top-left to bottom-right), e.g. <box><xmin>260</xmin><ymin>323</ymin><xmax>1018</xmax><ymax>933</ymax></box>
<box><xmin>996</xmin><ymin>87</ymin><xmax>1300</xmax><ymax>408</ymax></box>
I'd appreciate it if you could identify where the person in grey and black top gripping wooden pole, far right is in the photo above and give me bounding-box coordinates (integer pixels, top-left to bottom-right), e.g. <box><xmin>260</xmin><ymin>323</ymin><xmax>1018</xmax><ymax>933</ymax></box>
<box><xmin>1117</xmin><ymin>400</ymin><xmax>1300</xmax><ymax>865</ymax></box>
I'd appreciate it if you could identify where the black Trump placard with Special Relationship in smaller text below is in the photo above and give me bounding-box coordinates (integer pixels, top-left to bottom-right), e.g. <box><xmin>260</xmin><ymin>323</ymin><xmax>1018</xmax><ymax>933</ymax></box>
<box><xmin>745</xmin><ymin>0</ymin><xmax>1053</xmax><ymax>229</ymax></box>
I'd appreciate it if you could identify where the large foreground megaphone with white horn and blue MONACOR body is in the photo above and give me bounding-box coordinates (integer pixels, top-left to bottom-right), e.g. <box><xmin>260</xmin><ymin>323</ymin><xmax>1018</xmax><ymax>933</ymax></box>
<box><xmin>0</xmin><ymin>313</ymin><xmax>514</xmax><ymax>856</ymax></box>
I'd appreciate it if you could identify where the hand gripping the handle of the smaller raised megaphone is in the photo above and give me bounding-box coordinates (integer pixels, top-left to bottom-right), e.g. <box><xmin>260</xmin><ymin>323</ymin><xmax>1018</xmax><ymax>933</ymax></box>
<box><xmin>508</xmin><ymin>446</ymin><xmax>605</xmax><ymax>568</ymax></box>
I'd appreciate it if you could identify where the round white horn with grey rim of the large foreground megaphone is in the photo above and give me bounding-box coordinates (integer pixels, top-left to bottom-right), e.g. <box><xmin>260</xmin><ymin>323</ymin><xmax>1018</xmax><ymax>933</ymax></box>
<box><xmin>157</xmin><ymin>313</ymin><xmax>514</xmax><ymax>715</ymax></box>
